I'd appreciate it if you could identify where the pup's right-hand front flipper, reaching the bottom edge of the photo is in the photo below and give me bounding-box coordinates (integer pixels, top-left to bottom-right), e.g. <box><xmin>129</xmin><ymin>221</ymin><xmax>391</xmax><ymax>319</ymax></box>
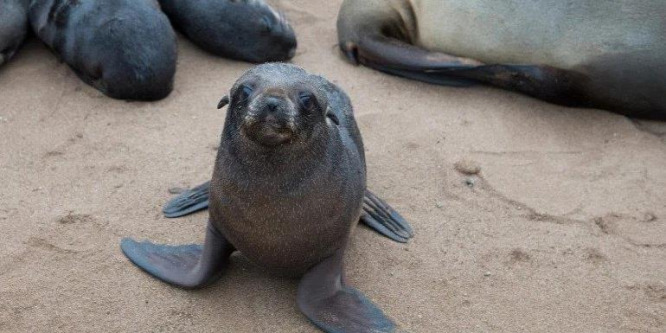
<box><xmin>296</xmin><ymin>249</ymin><xmax>397</xmax><ymax>333</ymax></box>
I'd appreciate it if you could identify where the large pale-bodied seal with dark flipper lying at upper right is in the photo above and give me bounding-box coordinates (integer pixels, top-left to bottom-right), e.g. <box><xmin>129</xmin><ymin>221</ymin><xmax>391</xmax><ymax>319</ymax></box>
<box><xmin>337</xmin><ymin>0</ymin><xmax>666</xmax><ymax>120</ymax></box>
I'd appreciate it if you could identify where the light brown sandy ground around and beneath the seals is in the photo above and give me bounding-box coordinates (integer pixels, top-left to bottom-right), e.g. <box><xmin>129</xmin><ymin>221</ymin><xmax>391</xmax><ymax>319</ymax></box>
<box><xmin>0</xmin><ymin>0</ymin><xmax>666</xmax><ymax>332</ymax></box>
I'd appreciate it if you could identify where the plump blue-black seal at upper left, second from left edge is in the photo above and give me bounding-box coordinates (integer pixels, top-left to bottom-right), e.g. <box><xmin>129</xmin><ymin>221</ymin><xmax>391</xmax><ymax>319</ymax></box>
<box><xmin>29</xmin><ymin>0</ymin><xmax>177</xmax><ymax>100</ymax></box>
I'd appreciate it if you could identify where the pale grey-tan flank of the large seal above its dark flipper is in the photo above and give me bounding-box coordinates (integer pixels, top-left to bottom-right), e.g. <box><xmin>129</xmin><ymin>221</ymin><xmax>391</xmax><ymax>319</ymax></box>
<box><xmin>413</xmin><ymin>0</ymin><xmax>666</xmax><ymax>69</ymax></box>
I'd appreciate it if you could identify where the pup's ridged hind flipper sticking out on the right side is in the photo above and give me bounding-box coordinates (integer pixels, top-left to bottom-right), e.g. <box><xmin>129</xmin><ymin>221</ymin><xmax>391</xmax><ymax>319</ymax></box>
<box><xmin>361</xmin><ymin>190</ymin><xmax>414</xmax><ymax>243</ymax></box>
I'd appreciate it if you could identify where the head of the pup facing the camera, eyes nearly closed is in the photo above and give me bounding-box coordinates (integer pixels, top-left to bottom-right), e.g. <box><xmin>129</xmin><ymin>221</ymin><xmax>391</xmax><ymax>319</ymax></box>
<box><xmin>218</xmin><ymin>63</ymin><xmax>328</xmax><ymax>148</ymax></box>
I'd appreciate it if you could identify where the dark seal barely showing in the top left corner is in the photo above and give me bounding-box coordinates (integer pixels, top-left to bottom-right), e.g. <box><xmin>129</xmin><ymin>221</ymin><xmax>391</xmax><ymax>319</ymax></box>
<box><xmin>0</xmin><ymin>0</ymin><xmax>28</xmax><ymax>65</ymax></box>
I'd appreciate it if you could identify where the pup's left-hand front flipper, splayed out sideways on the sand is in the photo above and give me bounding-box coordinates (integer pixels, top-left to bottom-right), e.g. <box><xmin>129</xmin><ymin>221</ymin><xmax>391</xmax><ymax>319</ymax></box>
<box><xmin>120</xmin><ymin>222</ymin><xmax>234</xmax><ymax>289</ymax></box>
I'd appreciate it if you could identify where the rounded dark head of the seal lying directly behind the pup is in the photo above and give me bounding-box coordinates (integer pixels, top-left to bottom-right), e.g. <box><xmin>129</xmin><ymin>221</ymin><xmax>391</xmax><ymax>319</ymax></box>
<box><xmin>219</xmin><ymin>0</ymin><xmax>297</xmax><ymax>63</ymax></box>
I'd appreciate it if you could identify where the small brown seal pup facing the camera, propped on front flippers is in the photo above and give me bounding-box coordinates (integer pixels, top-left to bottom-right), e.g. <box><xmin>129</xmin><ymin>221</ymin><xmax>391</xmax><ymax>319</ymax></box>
<box><xmin>121</xmin><ymin>63</ymin><xmax>410</xmax><ymax>332</ymax></box>
